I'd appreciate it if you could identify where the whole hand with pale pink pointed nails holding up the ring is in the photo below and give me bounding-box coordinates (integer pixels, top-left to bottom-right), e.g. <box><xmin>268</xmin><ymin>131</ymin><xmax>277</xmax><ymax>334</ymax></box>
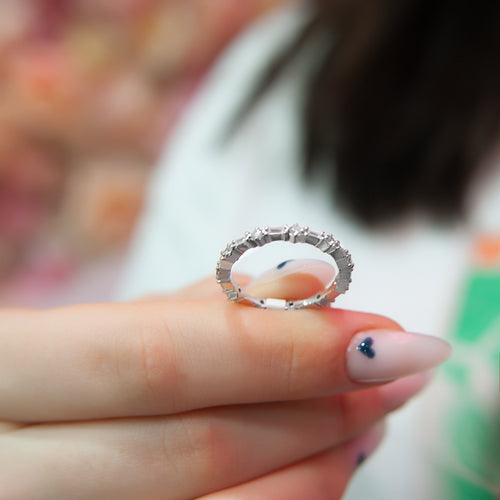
<box><xmin>0</xmin><ymin>264</ymin><xmax>448</xmax><ymax>500</ymax></box>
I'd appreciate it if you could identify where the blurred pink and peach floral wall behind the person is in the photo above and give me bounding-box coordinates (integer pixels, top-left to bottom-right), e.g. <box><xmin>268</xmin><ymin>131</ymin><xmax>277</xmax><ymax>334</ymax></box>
<box><xmin>0</xmin><ymin>0</ymin><xmax>286</xmax><ymax>307</ymax></box>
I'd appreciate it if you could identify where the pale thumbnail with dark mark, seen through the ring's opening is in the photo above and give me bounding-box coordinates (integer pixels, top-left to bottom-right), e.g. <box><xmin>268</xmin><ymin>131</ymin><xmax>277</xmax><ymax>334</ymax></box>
<box><xmin>247</xmin><ymin>259</ymin><xmax>336</xmax><ymax>290</ymax></box>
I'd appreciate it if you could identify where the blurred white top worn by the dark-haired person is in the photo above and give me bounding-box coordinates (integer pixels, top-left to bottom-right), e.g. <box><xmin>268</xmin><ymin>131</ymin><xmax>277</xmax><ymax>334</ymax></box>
<box><xmin>119</xmin><ymin>4</ymin><xmax>500</xmax><ymax>500</ymax></box>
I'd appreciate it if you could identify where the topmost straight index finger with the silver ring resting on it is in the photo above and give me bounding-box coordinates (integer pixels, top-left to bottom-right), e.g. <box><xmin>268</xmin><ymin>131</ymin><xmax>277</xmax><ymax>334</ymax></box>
<box><xmin>0</xmin><ymin>300</ymin><xmax>448</xmax><ymax>421</ymax></box>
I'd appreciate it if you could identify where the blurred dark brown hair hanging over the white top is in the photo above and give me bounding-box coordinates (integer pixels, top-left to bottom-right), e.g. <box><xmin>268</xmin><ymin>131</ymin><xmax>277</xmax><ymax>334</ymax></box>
<box><xmin>232</xmin><ymin>0</ymin><xmax>500</xmax><ymax>225</ymax></box>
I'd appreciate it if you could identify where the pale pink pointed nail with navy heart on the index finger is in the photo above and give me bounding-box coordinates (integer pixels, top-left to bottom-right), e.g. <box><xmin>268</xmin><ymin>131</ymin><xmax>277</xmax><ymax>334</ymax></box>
<box><xmin>347</xmin><ymin>330</ymin><xmax>451</xmax><ymax>382</ymax></box>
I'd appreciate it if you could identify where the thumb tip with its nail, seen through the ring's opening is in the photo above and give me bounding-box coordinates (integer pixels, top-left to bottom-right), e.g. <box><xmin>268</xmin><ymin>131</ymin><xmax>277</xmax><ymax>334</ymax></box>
<box><xmin>245</xmin><ymin>259</ymin><xmax>337</xmax><ymax>300</ymax></box>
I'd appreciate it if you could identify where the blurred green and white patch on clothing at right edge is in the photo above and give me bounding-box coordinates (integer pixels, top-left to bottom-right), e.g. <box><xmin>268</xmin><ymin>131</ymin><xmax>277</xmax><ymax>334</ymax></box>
<box><xmin>438</xmin><ymin>267</ymin><xmax>500</xmax><ymax>500</ymax></box>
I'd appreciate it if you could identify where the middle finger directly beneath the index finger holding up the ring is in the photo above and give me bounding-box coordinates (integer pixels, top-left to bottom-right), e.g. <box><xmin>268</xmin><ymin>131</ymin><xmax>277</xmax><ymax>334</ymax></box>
<box><xmin>0</xmin><ymin>375</ymin><xmax>426</xmax><ymax>500</ymax></box>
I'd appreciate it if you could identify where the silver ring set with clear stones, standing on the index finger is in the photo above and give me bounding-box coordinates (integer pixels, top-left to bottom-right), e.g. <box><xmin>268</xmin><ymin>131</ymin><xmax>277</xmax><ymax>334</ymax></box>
<box><xmin>216</xmin><ymin>224</ymin><xmax>354</xmax><ymax>310</ymax></box>
